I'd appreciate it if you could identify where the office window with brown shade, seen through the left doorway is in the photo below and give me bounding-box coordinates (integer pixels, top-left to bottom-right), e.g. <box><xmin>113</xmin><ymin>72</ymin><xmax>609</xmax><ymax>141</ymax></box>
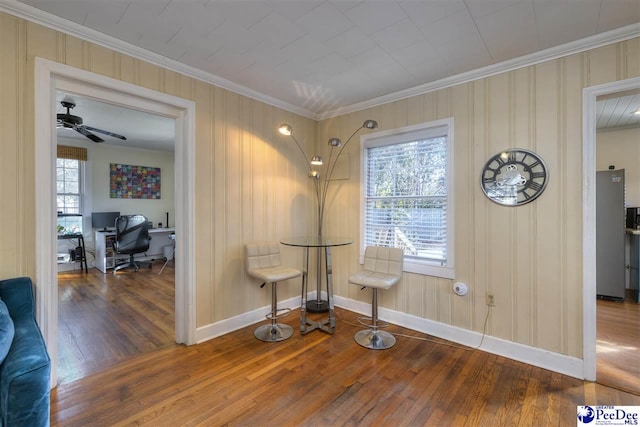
<box><xmin>56</xmin><ymin>146</ymin><xmax>86</xmax><ymax>233</ymax></box>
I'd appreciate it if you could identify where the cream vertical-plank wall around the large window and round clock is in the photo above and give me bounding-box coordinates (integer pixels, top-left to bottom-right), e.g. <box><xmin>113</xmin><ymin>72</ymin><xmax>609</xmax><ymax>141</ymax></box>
<box><xmin>317</xmin><ymin>38</ymin><xmax>640</xmax><ymax>357</ymax></box>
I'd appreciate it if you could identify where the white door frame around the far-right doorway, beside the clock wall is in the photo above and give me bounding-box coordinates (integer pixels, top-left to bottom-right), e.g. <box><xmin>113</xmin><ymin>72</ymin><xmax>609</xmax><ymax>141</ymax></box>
<box><xmin>582</xmin><ymin>77</ymin><xmax>640</xmax><ymax>381</ymax></box>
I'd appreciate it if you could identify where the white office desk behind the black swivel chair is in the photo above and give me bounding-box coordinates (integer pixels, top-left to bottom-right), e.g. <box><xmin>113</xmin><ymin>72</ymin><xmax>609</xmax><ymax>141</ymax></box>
<box><xmin>94</xmin><ymin>228</ymin><xmax>176</xmax><ymax>273</ymax></box>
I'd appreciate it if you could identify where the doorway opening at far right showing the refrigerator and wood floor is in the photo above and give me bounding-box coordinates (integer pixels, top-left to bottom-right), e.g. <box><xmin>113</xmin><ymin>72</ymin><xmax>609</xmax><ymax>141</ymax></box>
<box><xmin>596</xmin><ymin>88</ymin><xmax>640</xmax><ymax>395</ymax></box>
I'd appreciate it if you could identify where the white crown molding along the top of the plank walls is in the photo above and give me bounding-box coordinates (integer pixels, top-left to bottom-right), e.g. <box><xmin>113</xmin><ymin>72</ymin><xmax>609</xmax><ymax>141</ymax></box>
<box><xmin>0</xmin><ymin>0</ymin><xmax>640</xmax><ymax>120</ymax></box>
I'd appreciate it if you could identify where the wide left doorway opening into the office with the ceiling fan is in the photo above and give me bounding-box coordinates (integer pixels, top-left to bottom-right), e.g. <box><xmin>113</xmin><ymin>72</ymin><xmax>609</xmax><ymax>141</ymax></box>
<box><xmin>56</xmin><ymin>91</ymin><xmax>175</xmax><ymax>384</ymax></box>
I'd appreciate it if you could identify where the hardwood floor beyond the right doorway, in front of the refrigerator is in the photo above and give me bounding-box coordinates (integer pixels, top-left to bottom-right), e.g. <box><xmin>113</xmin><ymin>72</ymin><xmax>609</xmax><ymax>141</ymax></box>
<box><xmin>596</xmin><ymin>298</ymin><xmax>640</xmax><ymax>396</ymax></box>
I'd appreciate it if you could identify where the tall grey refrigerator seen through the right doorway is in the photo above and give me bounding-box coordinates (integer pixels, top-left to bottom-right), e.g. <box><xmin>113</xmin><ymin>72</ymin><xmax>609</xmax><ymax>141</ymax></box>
<box><xmin>596</xmin><ymin>169</ymin><xmax>625</xmax><ymax>299</ymax></box>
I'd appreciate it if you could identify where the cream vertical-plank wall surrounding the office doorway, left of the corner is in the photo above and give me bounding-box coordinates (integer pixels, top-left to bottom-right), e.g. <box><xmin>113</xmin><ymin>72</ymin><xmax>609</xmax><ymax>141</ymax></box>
<box><xmin>0</xmin><ymin>13</ymin><xmax>316</xmax><ymax>326</ymax></box>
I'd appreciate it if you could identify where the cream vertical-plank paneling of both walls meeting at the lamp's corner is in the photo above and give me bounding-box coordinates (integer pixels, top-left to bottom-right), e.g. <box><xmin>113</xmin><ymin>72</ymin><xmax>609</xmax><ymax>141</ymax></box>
<box><xmin>0</xmin><ymin>13</ymin><xmax>640</xmax><ymax>357</ymax></box>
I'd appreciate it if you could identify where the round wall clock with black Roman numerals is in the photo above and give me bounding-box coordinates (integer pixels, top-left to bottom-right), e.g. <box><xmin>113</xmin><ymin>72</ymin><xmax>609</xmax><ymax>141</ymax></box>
<box><xmin>480</xmin><ymin>148</ymin><xmax>549</xmax><ymax>206</ymax></box>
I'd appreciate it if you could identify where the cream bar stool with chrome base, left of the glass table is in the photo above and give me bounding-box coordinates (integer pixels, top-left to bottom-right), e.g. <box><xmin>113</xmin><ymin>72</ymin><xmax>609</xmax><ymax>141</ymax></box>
<box><xmin>245</xmin><ymin>242</ymin><xmax>302</xmax><ymax>342</ymax></box>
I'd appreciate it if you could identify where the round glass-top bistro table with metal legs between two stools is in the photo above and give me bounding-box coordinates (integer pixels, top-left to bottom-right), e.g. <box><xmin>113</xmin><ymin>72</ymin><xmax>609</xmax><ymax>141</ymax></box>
<box><xmin>280</xmin><ymin>236</ymin><xmax>353</xmax><ymax>334</ymax></box>
